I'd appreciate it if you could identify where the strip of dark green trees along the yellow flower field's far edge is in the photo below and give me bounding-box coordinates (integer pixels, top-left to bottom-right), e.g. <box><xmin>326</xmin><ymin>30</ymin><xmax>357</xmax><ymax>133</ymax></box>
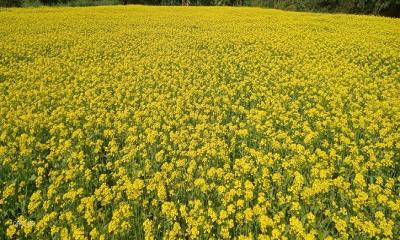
<box><xmin>0</xmin><ymin>0</ymin><xmax>400</xmax><ymax>17</ymax></box>
